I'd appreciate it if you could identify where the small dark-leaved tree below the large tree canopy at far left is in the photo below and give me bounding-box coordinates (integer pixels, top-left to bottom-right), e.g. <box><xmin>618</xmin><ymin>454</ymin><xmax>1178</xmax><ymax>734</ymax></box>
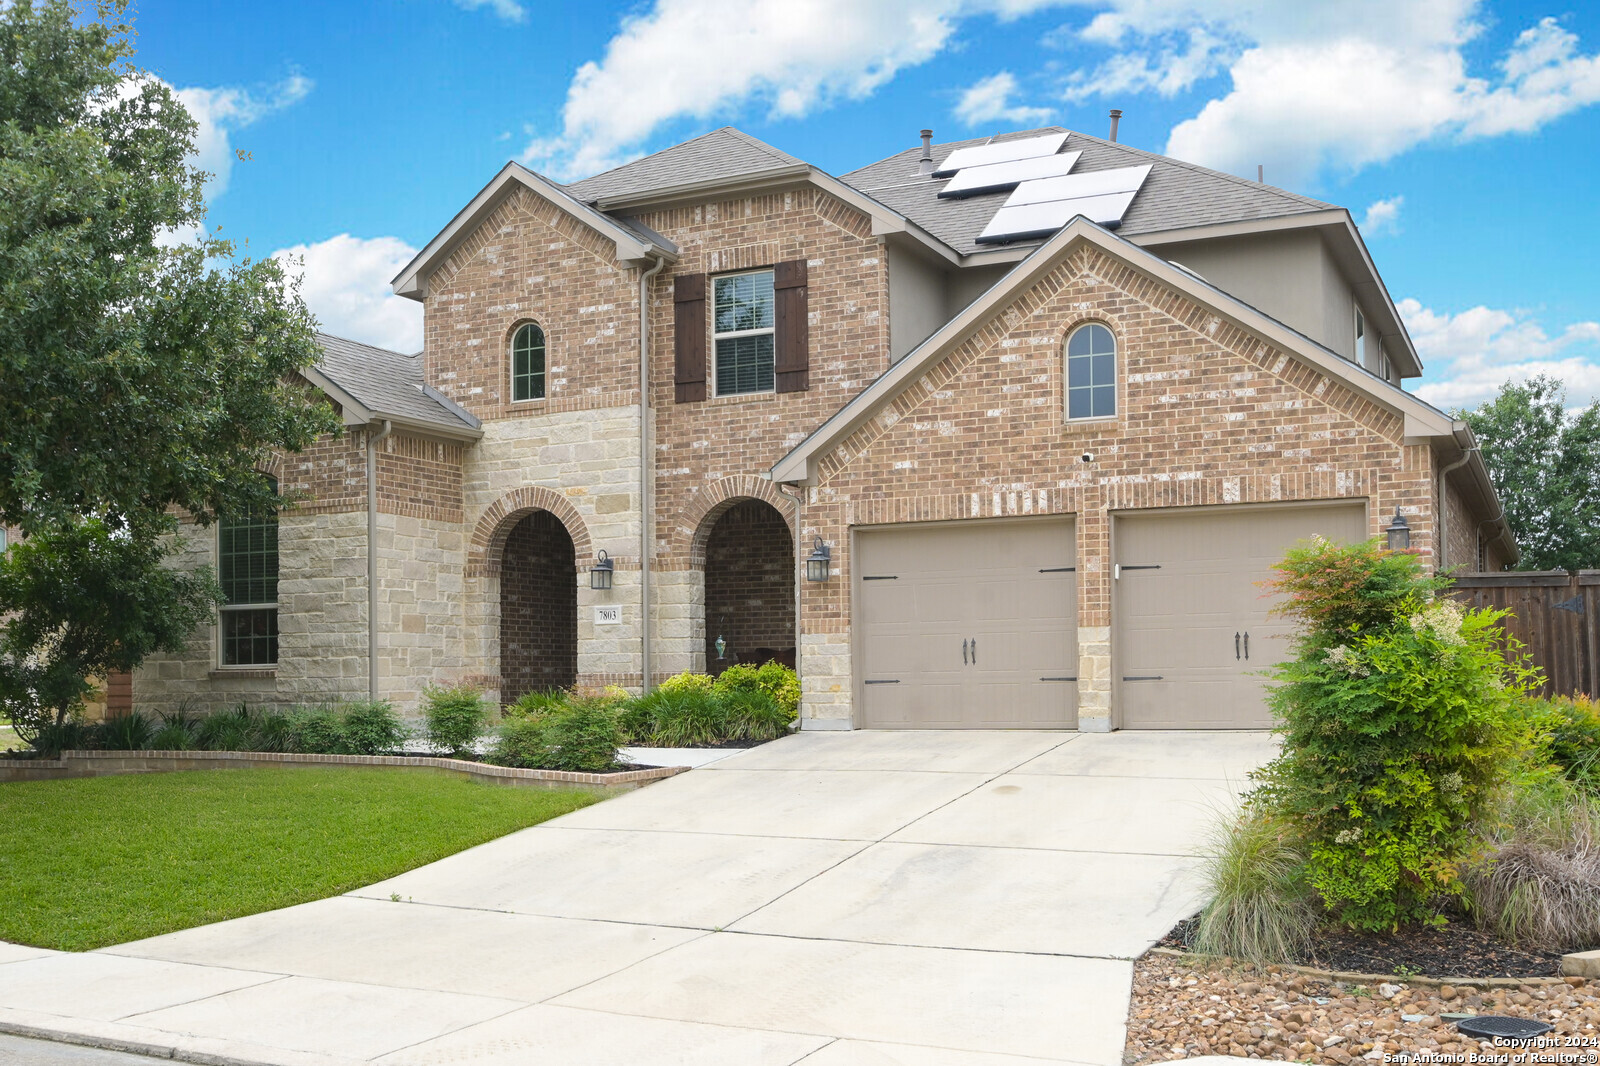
<box><xmin>0</xmin><ymin>519</ymin><xmax>222</xmax><ymax>744</ymax></box>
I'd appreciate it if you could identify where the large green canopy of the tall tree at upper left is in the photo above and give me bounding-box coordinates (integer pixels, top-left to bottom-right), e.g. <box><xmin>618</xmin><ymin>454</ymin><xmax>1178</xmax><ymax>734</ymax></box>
<box><xmin>0</xmin><ymin>0</ymin><xmax>336</xmax><ymax>535</ymax></box>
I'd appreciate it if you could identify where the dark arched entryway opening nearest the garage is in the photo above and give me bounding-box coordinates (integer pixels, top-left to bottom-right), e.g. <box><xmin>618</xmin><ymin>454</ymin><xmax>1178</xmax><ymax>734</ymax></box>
<box><xmin>706</xmin><ymin>498</ymin><xmax>795</xmax><ymax>674</ymax></box>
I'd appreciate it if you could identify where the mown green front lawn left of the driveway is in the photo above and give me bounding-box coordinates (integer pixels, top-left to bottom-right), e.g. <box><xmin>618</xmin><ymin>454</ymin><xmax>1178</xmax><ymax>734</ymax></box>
<box><xmin>0</xmin><ymin>768</ymin><xmax>600</xmax><ymax>951</ymax></box>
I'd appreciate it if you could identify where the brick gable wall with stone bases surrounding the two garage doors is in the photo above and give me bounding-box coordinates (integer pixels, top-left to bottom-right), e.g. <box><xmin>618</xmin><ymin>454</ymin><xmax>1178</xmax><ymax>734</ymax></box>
<box><xmin>802</xmin><ymin>245</ymin><xmax>1434</xmax><ymax>728</ymax></box>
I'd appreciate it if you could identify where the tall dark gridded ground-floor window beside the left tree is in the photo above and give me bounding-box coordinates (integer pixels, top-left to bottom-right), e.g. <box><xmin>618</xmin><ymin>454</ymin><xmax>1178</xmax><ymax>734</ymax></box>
<box><xmin>216</xmin><ymin>479</ymin><xmax>278</xmax><ymax>666</ymax></box>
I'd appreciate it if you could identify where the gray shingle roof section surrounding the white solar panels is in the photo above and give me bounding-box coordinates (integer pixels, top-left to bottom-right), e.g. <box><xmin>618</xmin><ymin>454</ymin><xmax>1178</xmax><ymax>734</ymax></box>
<box><xmin>842</xmin><ymin>126</ymin><xmax>1333</xmax><ymax>254</ymax></box>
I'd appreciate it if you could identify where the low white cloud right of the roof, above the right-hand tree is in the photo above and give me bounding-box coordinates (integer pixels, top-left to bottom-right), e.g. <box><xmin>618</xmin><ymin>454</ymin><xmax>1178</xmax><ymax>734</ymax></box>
<box><xmin>1398</xmin><ymin>299</ymin><xmax>1600</xmax><ymax>410</ymax></box>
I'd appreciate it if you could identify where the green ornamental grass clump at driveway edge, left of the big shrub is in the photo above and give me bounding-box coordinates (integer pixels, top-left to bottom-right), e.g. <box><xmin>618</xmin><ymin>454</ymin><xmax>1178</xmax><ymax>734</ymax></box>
<box><xmin>1190</xmin><ymin>808</ymin><xmax>1317</xmax><ymax>967</ymax></box>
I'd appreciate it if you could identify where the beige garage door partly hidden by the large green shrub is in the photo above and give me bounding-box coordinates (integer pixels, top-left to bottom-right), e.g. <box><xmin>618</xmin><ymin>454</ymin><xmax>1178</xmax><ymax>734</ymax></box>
<box><xmin>1112</xmin><ymin>504</ymin><xmax>1366</xmax><ymax>730</ymax></box>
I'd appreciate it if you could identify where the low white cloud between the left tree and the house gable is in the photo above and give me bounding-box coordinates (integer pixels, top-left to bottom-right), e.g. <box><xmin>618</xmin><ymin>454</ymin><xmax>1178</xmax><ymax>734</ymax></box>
<box><xmin>272</xmin><ymin>234</ymin><xmax>422</xmax><ymax>354</ymax></box>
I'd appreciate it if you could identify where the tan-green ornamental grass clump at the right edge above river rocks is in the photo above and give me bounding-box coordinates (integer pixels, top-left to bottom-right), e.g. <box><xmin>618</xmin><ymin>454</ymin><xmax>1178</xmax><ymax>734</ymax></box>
<box><xmin>1464</xmin><ymin>770</ymin><xmax>1600</xmax><ymax>951</ymax></box>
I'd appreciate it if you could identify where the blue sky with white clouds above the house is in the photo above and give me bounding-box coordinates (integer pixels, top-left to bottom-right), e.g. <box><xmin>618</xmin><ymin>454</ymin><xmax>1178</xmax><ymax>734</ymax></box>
<box><xmin>136</xmin><ymin>0</ymin><xmax>1600</xmax><ymax>407</ymax></box>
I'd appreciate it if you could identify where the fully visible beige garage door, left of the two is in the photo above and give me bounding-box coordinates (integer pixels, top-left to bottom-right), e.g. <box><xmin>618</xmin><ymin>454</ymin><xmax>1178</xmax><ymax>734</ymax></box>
<box><xmin>854</xmin><ymin>517</ymin><xmax>1078</xmax><ymax>730</ymax></box>
